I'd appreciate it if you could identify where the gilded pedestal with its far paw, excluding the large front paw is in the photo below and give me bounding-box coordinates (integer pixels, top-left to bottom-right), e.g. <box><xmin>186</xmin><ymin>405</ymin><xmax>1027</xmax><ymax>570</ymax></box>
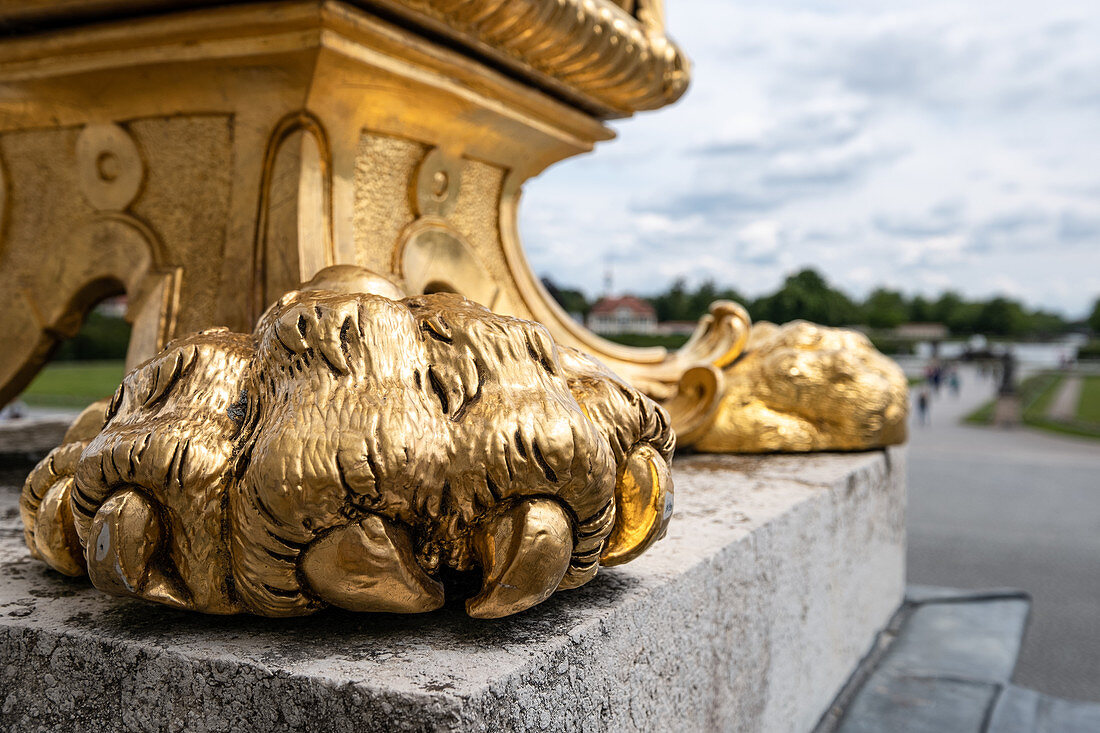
<box><xmin>0</xmin><ymin>0</ymin><xmax>905</xmax><ymax>450</ymax></box>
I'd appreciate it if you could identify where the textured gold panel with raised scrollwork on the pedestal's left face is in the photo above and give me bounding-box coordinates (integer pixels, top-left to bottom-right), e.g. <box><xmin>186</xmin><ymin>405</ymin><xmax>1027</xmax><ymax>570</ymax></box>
<box><xmin>0</xmin><ymin>117</ymin><xmax>228</xmax><ymax>403</ymax></box>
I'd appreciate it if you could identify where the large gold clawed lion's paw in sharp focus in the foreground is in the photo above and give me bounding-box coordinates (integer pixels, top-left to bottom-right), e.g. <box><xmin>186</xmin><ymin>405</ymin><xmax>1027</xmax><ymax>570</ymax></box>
<box><xmin>21</xmin><ymin>266</ymin><xmax>674</xmax><ymax>617</ymax></box>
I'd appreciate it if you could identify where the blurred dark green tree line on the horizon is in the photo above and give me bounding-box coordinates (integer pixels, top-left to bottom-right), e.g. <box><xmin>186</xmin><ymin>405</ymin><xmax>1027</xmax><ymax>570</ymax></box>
<box><xmin>543</xmin><ymin>269</ymin><xmax>1100</xmax><ymax>337</ymax></box>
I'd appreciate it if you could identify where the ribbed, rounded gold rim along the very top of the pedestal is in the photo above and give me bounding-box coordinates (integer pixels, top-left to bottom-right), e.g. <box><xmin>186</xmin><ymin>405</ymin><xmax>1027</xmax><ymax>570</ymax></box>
<box><xmin>0</xmin><ymin>0</ymin><xmax>690</xmax><ymax>117</ymax></box>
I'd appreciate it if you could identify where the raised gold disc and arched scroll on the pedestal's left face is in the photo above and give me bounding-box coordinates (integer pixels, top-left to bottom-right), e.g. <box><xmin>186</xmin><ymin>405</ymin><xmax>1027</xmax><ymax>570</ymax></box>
<box><xmin>0</xmin><ymin>122</ymin><xmax>183</xmax><ymax>404</ymax></box>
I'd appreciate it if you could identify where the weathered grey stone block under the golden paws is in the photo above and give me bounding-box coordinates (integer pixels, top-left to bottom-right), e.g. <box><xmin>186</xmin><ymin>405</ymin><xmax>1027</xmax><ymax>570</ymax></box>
<box><xmin>0</xmin><ymin>450</ymin><xmax>905</xmax><ymax>733</ymax></box>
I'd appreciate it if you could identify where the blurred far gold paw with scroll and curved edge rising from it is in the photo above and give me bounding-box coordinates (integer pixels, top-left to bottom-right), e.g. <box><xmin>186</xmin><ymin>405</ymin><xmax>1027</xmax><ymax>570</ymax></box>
<box><xmin>501</xmin><ymin>171</ymin><xmax>908</xmax><ymax>452</ymax></box>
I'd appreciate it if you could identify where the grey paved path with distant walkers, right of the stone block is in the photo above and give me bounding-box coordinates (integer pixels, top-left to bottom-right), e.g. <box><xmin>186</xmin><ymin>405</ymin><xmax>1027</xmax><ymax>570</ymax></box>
<box><xmin>909</xmin><ymin>370</ymin><xmax>1100</xmax><ymax>701</ymax></box>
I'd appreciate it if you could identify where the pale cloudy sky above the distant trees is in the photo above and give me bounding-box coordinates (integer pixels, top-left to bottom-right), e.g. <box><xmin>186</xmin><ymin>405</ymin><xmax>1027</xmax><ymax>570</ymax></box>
<box><xmin>520</xmin><ymin>0</ymin><xmax>1100</xmax><ymax>316</ymax></box>
